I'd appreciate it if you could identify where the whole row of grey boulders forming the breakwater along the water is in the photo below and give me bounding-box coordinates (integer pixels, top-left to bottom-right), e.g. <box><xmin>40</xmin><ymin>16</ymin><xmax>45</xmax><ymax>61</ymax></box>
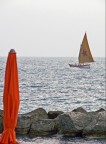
<box><xmin>0</xmin><ymin>107</ymin><xmax>106</xmax><ymax>138</ymax></box>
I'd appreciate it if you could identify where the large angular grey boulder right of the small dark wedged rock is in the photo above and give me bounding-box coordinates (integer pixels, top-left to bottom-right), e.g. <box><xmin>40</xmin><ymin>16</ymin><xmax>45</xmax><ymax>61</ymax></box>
<box><xmin>59</xmin><ymin>112</ymin><xmax>92</xmax><ymax>136</ymax></box>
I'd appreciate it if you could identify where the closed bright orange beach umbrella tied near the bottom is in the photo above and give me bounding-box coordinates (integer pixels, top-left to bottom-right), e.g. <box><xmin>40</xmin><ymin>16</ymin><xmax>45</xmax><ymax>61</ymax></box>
<box><xmin>0</xmin><ymin>49</ymin><xmax>20</xmax><ymax>144</ymax></box>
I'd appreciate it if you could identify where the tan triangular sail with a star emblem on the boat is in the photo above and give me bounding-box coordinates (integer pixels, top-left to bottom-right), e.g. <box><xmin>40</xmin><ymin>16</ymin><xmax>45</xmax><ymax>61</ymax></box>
<box><xmin>79</xmin><ymin>33</ymin><xmax>94</xmax><ymax>63</ymax></box>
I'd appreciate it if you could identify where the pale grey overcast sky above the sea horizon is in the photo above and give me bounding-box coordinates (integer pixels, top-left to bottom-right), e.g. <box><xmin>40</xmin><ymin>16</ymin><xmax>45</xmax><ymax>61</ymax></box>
<box><xmin>0</xmin><ymin>0</ymin><xmax>105</xmax><ymax>57</ymax></box>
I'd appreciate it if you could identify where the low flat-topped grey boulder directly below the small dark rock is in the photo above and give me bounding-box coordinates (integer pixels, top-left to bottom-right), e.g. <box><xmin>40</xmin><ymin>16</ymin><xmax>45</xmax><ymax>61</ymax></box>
<box><xmin>29</xmin><ymin>119</ymin><xmax>58</xmax><ymax>137</ymax></box>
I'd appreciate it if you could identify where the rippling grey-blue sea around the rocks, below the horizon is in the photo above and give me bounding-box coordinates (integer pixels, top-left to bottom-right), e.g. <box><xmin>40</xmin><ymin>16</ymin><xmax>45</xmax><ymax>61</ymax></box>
<box><xmin>0</xmin><ymin>57</ymin><xmax>106</xmax><ymax>144</ymax></box>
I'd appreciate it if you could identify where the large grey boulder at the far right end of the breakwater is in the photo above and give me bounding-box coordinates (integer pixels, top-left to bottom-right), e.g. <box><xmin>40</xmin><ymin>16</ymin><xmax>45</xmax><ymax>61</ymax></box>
<box><xmin>83</xmin><ymin>111</ymin><xmax>106</xmax><ymax>138</ymax></box>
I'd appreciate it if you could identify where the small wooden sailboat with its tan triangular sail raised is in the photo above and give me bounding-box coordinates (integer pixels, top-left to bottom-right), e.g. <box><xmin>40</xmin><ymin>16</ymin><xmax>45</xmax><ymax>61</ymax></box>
<box><xmin>69</xmin><ymin>33</ymin><xmax>94</xmax><ymax>68</ymax></box>
